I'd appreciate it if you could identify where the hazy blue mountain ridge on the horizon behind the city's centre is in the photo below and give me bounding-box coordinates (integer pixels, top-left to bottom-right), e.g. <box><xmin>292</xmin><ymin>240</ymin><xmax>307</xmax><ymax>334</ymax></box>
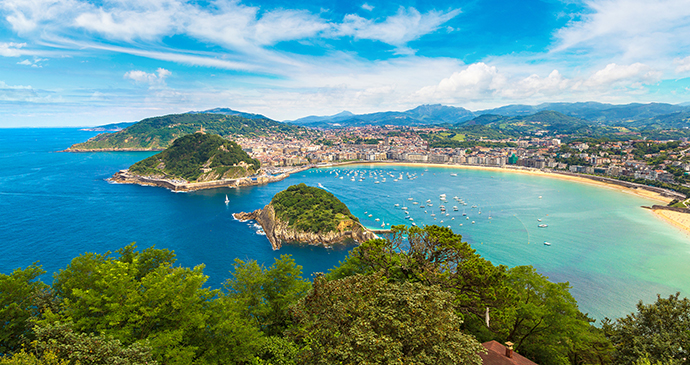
<box><xmin>286</xmin><ymin>104</ymin><xmax>474</xmax><ymax>128</ymax></box>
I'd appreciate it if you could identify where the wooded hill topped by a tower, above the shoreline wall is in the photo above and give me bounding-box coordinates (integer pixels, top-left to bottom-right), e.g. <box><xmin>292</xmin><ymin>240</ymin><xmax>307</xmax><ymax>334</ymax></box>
<box><xmin>129</xmin><ymin>133</ymin><xmax>260</xmax><ymax>181</ymax></box>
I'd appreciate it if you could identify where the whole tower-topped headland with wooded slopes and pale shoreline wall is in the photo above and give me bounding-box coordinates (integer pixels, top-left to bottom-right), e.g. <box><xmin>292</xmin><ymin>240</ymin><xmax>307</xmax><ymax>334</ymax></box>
<box><xmin>109</xmin><ymin>133</ymin><xmax>284</xmax><ymax>191</ymax></box>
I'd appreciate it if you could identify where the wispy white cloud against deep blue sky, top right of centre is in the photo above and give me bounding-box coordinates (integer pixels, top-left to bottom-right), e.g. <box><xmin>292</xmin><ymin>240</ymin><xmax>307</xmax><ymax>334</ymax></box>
<box><xmin>336</xmin><ymin>7</ymin><xmax>460</xmax><ymax>46</ymax></box>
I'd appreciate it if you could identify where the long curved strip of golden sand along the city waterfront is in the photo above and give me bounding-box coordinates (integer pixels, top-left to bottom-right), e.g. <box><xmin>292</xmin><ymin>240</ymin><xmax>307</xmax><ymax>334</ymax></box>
<box><xmin>330</xmin><ymin>161</ymin><xmax>690</xmax><ymax>235</ymax></box>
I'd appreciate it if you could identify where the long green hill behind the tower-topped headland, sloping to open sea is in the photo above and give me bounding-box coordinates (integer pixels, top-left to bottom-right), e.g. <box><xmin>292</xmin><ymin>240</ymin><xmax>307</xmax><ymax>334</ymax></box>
<box><xmin>67</xmin><ymin>113</ymin><xmax>303</xmax><ymax>151</ymax></box>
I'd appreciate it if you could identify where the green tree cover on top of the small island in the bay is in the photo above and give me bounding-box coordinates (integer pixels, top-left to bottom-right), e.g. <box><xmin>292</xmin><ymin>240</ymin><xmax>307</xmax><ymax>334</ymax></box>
<box><xmin>271</xmin><ymin>183</ymin><xmax>358</xmax><ymax>233</ymax></box>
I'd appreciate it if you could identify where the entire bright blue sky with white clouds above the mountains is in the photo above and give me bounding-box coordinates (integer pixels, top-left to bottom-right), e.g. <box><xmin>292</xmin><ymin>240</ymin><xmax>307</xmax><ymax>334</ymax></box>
<box><xmin>0</xmin><ymin>0</ymin><xmax>690</xmax><ymax>127</ymax></box>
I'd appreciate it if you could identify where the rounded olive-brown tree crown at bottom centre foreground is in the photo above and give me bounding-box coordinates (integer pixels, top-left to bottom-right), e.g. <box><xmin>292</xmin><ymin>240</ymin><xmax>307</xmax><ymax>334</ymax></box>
<box><xmin>289</xmin><ymin>274</ymin><xmax>483</xmax><ymax>364</ymax></box>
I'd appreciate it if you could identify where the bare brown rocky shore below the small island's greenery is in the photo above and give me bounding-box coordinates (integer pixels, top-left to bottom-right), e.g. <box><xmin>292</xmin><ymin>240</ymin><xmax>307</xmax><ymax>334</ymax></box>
<box><xmin>233</xmin><ymin>204</ymin><xmax>376</xmax><ymax>250</ymax></box>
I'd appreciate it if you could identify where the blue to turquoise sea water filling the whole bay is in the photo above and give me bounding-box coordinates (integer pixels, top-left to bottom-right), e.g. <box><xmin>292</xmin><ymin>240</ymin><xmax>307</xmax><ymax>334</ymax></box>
<box><xmin>0</xmin><ymin>129</ymin><xmax>690</xmax><ymax>319</ymax></box>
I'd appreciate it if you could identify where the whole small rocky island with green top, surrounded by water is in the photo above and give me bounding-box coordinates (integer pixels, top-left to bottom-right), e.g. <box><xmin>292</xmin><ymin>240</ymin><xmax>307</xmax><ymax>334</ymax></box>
<box><xmin>233</xmin><ymin>183</ymin><xmax>376</xmax><ymax>250</ymax></box>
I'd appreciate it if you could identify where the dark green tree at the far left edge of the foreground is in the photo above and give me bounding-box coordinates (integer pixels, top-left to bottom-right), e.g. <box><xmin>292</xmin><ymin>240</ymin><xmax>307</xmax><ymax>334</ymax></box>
<box><xmin>0</xmin><ymin>264</ymin><xmax>47</xmax><ymax>354</ymax></box>
